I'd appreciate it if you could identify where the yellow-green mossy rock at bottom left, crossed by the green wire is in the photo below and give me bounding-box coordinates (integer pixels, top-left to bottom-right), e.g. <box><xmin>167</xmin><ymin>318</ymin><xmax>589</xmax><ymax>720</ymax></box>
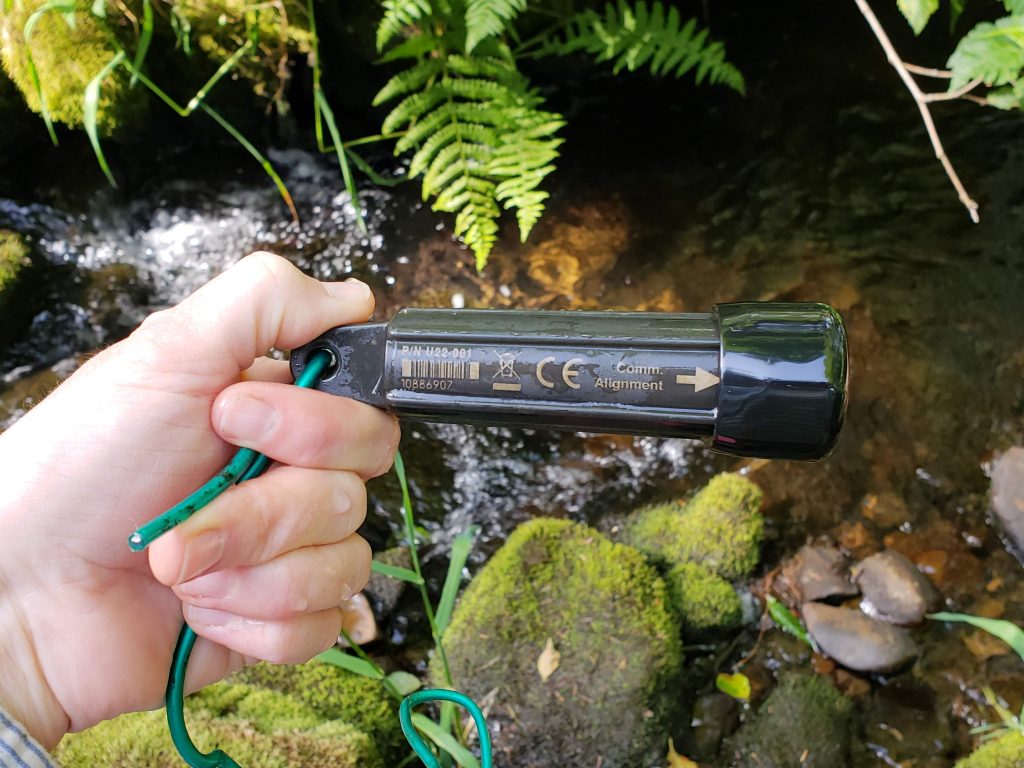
<box><xmin>56</xmin><ymin>682</ymin><xmax>389</xmax><ymax>768</ymax></box>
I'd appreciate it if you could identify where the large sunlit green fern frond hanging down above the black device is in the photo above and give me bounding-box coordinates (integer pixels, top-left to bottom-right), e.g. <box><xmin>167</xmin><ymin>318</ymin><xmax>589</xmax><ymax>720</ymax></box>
<box><xmin>376</xmin><ymin>45</ymin><xmax>564</xmax><ymax>269</ymax></box>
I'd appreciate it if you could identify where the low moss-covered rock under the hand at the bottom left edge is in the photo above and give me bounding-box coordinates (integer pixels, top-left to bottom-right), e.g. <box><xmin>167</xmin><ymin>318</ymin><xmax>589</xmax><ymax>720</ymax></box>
<box><xmin>56</xmin><ymin>663</ymin><xmax>398</xmax><ymax>768</ymax></box>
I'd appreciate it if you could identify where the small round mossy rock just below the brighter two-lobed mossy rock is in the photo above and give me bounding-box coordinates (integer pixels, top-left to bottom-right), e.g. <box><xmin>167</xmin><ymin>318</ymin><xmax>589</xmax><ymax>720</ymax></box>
<box><xmin>665</xmin><ymin>562</ymin><xmax>743</xmax><ymax>636</ymax></box>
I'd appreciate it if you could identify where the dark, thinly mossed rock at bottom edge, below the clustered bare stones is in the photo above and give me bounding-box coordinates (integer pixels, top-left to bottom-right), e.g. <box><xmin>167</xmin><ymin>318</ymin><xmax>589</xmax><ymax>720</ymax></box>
<box><xmin>723</xmin><ymin>674</ymin><xmax>853</xmax><ymax>768</ymax></box>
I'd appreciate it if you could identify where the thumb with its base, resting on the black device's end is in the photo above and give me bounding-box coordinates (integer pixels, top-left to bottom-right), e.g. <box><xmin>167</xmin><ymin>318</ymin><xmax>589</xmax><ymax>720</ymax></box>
<box><xmin>136</xmin><ymin>252</ymin><xmax>374</xmax><ymax>384</ymax></box>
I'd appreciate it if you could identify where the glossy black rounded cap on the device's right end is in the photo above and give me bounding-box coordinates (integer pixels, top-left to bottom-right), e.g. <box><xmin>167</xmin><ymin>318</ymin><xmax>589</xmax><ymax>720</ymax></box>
<box><xmin>714</xmin><ymin>303</ymin><xmax>849</xmax><ymax>460</ymax></box>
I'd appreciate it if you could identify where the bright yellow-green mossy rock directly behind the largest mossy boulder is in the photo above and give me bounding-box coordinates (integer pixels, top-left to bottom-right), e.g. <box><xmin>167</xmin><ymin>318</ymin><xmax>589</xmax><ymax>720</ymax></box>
<box><xmin>624</xmin><ymin>473</ymin><xmax>764</xmax><ymax>581</ymax></box>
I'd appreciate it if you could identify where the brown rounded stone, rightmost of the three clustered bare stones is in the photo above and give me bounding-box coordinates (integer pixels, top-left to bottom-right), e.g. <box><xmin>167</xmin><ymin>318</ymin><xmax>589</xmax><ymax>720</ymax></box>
<box><xmin>853</xmin><ymin>550</ymin><xmax>939</xmax><ymax>625</ymax></box>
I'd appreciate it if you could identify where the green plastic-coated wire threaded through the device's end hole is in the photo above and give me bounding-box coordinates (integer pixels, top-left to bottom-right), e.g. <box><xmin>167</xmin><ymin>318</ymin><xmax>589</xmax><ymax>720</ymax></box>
<box><xmin>128</xmin><ymin>352</ymin><xmax>492</xmax><ymax>768</ymax></box>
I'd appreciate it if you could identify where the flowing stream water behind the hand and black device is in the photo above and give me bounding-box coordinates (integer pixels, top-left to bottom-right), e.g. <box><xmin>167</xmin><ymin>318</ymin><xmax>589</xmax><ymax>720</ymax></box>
<box><xmin>0</xmin><ymin>4</ymin><xmax>1024</xmax><ymax>767</ymax></box>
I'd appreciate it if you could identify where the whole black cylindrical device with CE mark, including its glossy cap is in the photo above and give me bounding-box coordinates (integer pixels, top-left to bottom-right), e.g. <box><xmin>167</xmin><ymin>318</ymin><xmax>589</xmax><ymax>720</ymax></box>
<box><xmin>292</xmin><ymin>303</ymin><xmax>849</xmax><ymax>460</ymax></box>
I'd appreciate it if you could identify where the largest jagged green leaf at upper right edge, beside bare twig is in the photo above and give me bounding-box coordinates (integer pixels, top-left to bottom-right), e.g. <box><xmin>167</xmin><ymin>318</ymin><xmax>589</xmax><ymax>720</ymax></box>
<box><xmin>947</xmin><ymin>15</ymin><xmax>1024</xmax><ymax>91</ymax></box>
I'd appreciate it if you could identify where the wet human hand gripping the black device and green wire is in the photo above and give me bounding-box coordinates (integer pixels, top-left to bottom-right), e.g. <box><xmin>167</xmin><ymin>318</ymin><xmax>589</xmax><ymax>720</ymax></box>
<box><xmin>0</xmin><ymin>254</ymin><xmax>398</xmax><ymax>746</ymax></box>
